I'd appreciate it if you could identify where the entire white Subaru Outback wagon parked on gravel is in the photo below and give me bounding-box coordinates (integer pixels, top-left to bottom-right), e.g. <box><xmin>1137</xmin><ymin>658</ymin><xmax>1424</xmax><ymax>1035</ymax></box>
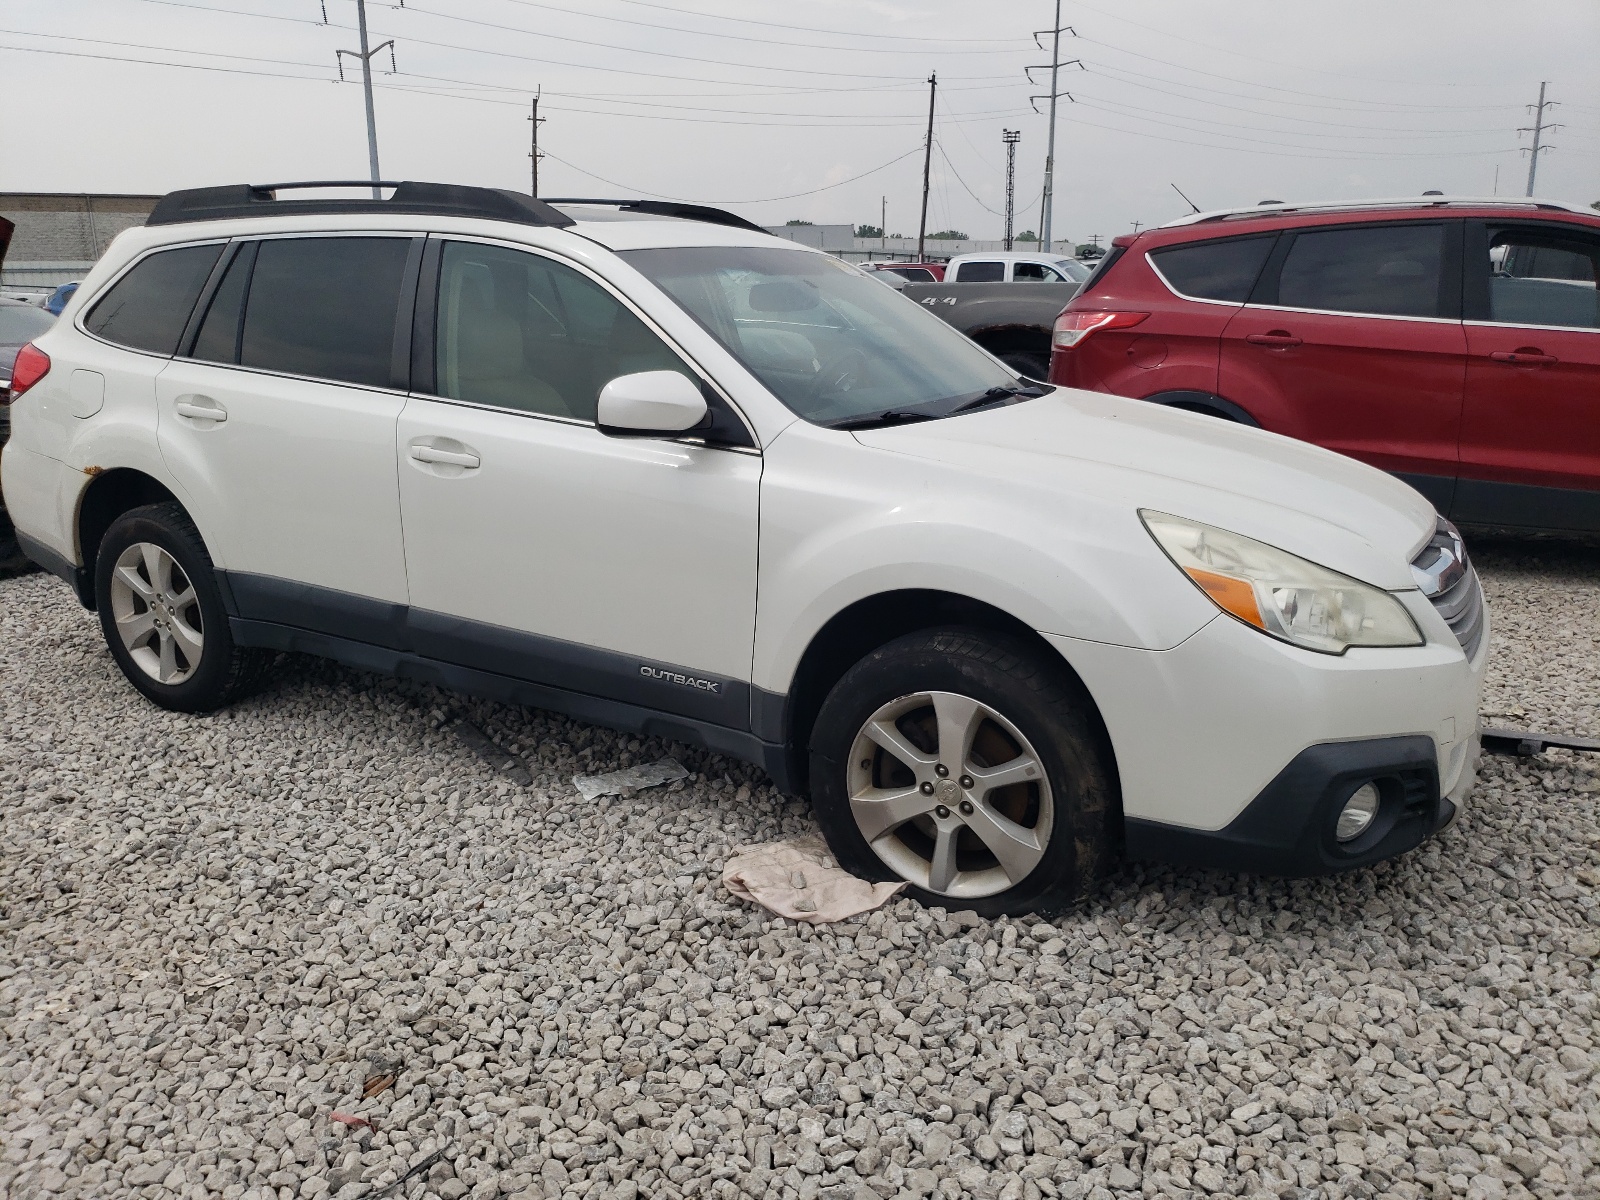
<box><xmin>3</xmin><ymin>182</ymin><xmax>1488</xmax><ymax>914</ymax></box>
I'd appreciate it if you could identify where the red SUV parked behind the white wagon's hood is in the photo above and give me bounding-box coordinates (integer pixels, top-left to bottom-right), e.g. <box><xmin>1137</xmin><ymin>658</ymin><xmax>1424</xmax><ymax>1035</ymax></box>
<box><xmin>1050</xmin><ymin>197</ymin><xmax>1600</xmax><ymax>531</ymax></box>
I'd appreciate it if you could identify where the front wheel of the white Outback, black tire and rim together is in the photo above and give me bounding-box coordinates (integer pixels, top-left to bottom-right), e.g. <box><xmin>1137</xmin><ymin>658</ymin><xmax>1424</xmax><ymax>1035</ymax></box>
<box><xmin>811</xmin><ymin>629</ymin><xmax>1120</xmax><ymax>917</ymax></box>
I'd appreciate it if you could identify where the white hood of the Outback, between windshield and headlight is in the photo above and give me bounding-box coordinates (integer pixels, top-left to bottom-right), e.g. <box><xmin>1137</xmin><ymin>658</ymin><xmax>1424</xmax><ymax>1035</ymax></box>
<box><xmin>856</xmin><ymin>389</ymin><xmax>1437</xmax><ymax>590</ymax></box>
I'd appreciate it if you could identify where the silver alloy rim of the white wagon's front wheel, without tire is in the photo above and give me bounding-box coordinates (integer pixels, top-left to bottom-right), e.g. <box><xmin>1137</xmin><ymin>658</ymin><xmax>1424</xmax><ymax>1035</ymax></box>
<box><xmin>848</xmin><ymin>691</ymin><xmax>1054</xmax><ymax>899</ymax></box>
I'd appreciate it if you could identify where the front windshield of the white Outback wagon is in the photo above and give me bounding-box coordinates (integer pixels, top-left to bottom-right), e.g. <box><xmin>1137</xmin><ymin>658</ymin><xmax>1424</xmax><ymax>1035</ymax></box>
<box><xmin>622</xmin><ymin>246</ymin><xmax>1019</xmax><ymax>424</ymax></box>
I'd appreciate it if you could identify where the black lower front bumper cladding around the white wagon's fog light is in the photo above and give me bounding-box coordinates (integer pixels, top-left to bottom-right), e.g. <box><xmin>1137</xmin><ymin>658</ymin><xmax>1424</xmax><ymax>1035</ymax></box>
<box><xmin>1126</xmin><ymin>734</ymin><xmax>1477</xmax><ymax>877</ymax></box>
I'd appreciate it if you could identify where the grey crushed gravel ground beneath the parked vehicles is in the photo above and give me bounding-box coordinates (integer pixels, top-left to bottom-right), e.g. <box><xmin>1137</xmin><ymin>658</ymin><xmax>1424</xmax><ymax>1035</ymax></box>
<box><xmin>0</xmin><ymin>542</ymin><xmax>1600</xmax><ymax>1200</ymax></box>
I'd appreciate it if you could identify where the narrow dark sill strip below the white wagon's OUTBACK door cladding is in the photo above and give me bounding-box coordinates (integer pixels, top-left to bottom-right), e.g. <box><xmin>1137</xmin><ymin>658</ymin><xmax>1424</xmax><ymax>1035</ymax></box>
<box><xmin>229</xmin><ymin>618</ymin><xmax>794</xmax><ymax>792</ymax></box>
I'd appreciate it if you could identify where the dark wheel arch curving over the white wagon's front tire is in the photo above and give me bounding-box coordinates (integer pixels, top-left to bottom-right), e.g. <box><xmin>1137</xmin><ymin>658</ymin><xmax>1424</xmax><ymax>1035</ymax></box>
<box><xmin>782</xmin><ymin>589</ymin><xmax>1115</xmax><ymax>790</ymax></box>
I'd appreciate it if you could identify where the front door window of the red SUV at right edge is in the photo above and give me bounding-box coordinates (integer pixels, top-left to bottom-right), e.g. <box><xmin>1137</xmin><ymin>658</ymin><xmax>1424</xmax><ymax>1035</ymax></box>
<box><xmin>1490</xmin><ymin>229</ymin><xmax>1600</xmax><ymax>330</ymax></box>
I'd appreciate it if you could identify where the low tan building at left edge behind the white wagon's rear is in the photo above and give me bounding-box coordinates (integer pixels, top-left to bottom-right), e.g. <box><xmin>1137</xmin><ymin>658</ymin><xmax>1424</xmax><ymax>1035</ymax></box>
<box><xmin>0</xmin><ymin>192</ymin><xmax>160</xmax><ymax>290</ymax></box>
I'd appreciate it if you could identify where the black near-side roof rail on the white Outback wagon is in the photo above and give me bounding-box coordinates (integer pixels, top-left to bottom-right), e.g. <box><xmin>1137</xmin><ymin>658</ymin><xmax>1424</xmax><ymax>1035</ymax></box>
<box><xmin>146</xmin><ymin>179</ymin><xmax>573</xmax><ymax>226</ymax></box>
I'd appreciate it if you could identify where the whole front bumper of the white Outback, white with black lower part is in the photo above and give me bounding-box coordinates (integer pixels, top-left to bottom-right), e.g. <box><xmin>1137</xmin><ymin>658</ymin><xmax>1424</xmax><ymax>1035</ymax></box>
<box><xmin>1045</xmin><ymin>592</ymin><xmax>1488</xmax><ymax>874</ymax></box>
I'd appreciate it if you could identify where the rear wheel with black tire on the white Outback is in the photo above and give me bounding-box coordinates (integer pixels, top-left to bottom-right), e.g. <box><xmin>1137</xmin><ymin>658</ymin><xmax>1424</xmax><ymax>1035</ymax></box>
<box><xmin>94</xmin><ymin>501</ymin><xmax>267</xmax><ymax>712</ymax></box>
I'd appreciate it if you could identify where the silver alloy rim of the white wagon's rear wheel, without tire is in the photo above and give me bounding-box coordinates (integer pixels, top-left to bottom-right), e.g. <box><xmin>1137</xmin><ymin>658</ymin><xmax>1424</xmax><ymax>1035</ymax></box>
<box><xmin>110</xmin><ymin>542</ymin><xmax>205</xmax><ymax>685</ymax></box>
